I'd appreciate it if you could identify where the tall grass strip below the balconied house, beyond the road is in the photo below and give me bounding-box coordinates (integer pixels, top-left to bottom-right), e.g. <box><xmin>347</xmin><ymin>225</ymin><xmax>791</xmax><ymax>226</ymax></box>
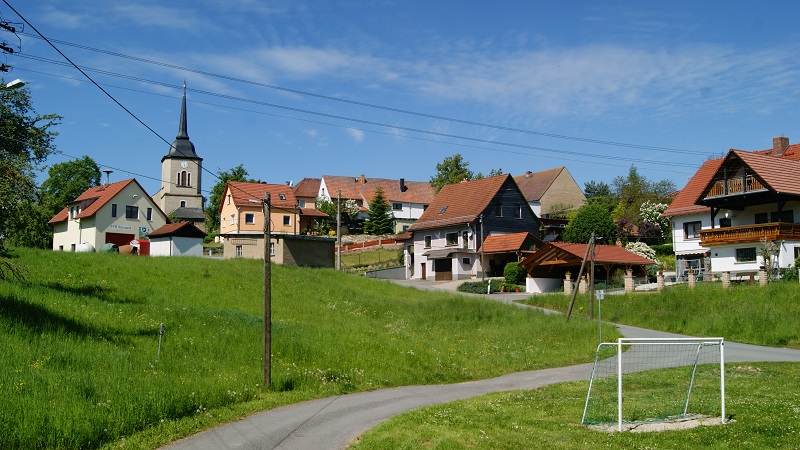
<box><xmin>527</xmin><ymin>282</ymin><xmax>800</xmax><ymax>348</ymax></box>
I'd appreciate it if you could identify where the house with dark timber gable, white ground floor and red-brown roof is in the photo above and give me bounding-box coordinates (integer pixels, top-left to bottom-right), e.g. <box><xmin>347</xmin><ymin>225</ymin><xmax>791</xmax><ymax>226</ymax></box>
<box><xmin>405</xmin><ymin>175</ymin><xmax>541</xmax><ymax>280</ymax></box>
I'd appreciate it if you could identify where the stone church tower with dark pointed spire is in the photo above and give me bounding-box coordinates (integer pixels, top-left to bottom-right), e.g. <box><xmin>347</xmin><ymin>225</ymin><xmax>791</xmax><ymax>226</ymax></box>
<box><xmin>154</xmin><ymin>83</ymin><xmax>205</xmax><ymax>230</ymax></box>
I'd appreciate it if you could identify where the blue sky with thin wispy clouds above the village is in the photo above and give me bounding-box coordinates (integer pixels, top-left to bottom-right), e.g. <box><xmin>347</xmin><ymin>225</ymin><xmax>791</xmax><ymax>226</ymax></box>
<box><xmin>0</xmin><ymin>0</ymin><xmax>800</xmax><ymax>199</ymax></box>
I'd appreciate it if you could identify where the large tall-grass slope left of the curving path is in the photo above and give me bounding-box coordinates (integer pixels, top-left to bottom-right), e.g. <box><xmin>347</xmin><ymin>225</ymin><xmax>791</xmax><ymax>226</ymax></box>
<box><xmin>0</xmin><ymin>249</ymin><xmax>614</xmax><ymax>449</ymax></box>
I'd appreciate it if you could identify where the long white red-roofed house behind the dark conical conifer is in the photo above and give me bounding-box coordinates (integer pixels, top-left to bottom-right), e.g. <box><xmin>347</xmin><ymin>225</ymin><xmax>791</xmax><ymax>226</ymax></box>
<box><xmin>314</xmin><ymin>174</ymin><xmax>436</xmax><ymax>233</ymax></box>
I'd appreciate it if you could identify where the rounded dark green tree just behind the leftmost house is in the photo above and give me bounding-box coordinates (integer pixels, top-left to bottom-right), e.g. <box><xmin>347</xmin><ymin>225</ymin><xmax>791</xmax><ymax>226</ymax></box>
<box><xmin>6</xmin><ymin>156</ymin><xmax>100</xmax><ymax>248</ymax></box>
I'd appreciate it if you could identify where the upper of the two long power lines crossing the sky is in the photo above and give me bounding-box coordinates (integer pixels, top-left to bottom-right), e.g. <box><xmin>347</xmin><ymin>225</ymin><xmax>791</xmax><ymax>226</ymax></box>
<box><xmin>15</xmin><ymin>31</ymin><xmax>707</xmax><ymax>155</ymax></box>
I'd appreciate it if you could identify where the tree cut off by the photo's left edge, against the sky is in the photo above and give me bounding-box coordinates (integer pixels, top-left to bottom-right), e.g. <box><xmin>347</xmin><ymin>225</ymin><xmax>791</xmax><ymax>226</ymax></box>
<box><xmin>0</xmin><ymin>80</ymin><xmax>61</xmax><ymax>253</ymax></box>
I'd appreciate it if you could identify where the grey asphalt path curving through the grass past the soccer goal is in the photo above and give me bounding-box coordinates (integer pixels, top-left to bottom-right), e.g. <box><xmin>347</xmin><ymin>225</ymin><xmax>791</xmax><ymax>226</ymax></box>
<box><xmin>162</xmin><ymin>284</ymin><xmax>800</xmax><ymax>450</ymax></box>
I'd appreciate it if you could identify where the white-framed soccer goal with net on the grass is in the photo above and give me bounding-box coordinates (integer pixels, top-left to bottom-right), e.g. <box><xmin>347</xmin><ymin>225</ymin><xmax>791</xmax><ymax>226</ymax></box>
<box><xmin>581</xmin><ymin>338</ymin><xmax>725</xmax><ymax>431</ymax></box>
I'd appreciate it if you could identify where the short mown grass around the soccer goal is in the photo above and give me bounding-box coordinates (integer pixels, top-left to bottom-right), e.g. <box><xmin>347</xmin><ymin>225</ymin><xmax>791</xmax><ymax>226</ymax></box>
<box><xmin>351</xmin><ymin>363</ymin><xmax>800</xmax><ymax>450</ymax></box>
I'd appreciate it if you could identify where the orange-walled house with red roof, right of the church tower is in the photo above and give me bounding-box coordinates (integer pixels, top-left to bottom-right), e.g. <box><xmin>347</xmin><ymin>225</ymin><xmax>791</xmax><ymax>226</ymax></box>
<box><xmin>219</xmin><ymin>181</ymin><xmax>335</xmax><ymax>267</ymax></box>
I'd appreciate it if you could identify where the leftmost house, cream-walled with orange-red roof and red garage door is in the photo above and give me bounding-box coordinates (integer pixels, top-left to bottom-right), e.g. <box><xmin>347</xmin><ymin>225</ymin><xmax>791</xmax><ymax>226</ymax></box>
<box><xmin>49</xmin><ymin>178</ymin><xmax>168</xmax><ymax>252</ymax></box>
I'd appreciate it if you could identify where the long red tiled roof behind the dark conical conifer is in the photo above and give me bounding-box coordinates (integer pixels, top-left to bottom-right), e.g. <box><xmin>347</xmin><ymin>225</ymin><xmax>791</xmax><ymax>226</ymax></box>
<box><xmin>314</xmin><ymin>175</ymin><xmax>436</xmax><ymax>206</ymax></box>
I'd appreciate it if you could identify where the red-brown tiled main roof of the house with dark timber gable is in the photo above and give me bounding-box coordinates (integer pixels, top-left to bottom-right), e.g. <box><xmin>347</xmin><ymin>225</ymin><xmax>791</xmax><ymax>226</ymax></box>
<box><xmin>409</xmin><ymin>174</ymin><xmax>513</xmax><ymax>231</ymax></box>
